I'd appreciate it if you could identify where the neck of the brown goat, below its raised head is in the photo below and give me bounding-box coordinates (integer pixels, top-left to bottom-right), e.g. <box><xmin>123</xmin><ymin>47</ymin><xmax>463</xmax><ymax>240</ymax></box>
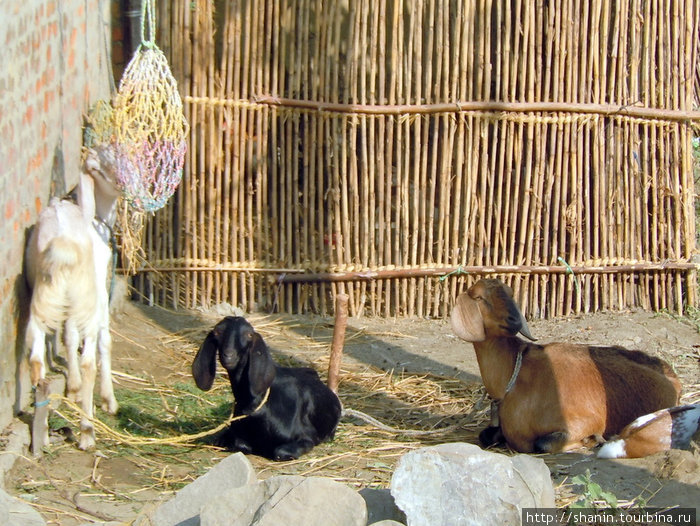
<box><xmin>474</xmin><ymin>336</ymin><xmax>524</xmax><ymax>400</ymax></box>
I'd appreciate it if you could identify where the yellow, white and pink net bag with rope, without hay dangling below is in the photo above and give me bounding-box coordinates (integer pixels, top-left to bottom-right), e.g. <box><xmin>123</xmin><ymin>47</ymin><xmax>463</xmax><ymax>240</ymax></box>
<box><xmin>106</xmin><ymin>0</ymin><xmax>188</xmax><ymax>212</ymax></box>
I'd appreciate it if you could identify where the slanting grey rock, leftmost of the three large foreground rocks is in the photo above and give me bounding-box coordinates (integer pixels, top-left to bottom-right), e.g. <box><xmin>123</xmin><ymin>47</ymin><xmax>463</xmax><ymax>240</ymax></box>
<box><xmin>150</xmin><ymin>453</ymin><xmax>257</xmax><ymax>526</ymax></box>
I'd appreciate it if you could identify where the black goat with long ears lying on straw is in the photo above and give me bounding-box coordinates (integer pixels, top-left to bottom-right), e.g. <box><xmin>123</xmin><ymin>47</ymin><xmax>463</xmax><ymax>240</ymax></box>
<box><xmin>192</xmin><ymin>316</ymin><xmax>341</xmax><ymax>460</ymax></box>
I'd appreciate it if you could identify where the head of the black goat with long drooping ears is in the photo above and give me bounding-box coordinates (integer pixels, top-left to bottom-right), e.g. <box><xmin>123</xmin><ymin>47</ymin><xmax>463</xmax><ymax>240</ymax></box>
<box><xmin>192</xmin><ymin>316</ymin><xmax>276</xmax><ymax>396</ymax></box>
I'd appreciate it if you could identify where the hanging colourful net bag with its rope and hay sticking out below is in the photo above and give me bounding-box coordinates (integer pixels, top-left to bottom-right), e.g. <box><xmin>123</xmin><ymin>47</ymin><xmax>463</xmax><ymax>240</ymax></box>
<box><xmin>84</xmin><ymin>0</ymin><xmax>188</xmax><ymax>274</ymax></box>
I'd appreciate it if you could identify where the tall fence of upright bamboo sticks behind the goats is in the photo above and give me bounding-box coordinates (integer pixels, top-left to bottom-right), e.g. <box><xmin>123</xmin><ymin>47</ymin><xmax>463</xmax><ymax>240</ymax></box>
<box><xmin>136</xmin><ymin>0</ymin><xmax>700</xmax><ymax>317</ymax></box>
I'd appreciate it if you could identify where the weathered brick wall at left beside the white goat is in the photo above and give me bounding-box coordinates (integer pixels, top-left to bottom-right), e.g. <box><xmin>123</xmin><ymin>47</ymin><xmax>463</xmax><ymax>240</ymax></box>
<box><xmin>0</xmin><ymin>0</ymin><xmax>112</xmax><ymax>430</ymax></box>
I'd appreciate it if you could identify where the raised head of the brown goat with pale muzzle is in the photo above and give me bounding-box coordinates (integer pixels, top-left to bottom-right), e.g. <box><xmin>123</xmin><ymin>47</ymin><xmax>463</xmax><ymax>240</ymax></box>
<box><xmin>452</xmin><ymin>279</ymin><xmax>534</xmax><ymax>342</ymax></box>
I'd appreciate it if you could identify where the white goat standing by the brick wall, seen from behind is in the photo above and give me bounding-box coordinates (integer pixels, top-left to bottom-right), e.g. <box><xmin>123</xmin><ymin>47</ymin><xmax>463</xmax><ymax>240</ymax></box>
<box><xmin>25</xmin><ymin>149</ymin><xmax>119</xmax><ymax>450</ymax></box>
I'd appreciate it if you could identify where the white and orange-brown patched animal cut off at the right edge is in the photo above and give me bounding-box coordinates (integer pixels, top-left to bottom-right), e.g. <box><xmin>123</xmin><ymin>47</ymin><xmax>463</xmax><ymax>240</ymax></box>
<box><xmin>598</xmin><ymin>404</ymin><xmax>700</xmax><ymax>458</ymax></box>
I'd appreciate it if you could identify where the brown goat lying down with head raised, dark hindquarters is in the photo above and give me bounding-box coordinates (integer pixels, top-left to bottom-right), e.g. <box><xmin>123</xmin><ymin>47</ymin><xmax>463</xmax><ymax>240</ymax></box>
<box><xmin>452</xmin><ymin>279</ymin><xmax>681</xmax><ymax>453</ymax></box>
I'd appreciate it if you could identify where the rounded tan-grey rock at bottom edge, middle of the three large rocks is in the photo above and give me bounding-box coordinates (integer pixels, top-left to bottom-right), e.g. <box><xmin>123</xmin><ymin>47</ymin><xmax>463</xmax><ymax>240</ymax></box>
<box><xmin>200</xmin><ymin>475</ymin><xmax>367</xmax><ymax>526</ymax></box>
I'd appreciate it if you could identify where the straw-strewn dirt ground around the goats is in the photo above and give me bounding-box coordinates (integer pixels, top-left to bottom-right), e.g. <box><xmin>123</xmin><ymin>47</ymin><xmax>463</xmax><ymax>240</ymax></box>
<box><xmin>5</xmin><ymin>304</ymin><xmax>700</xmax><ymax>526</ymax></box>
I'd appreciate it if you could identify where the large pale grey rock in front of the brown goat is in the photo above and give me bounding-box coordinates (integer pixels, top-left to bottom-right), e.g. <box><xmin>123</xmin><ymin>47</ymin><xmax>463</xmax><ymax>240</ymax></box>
<box><xmin>391</xmin><ymin>443</ymin><xmax>554</xmax><ymax>526</ymax></box>
